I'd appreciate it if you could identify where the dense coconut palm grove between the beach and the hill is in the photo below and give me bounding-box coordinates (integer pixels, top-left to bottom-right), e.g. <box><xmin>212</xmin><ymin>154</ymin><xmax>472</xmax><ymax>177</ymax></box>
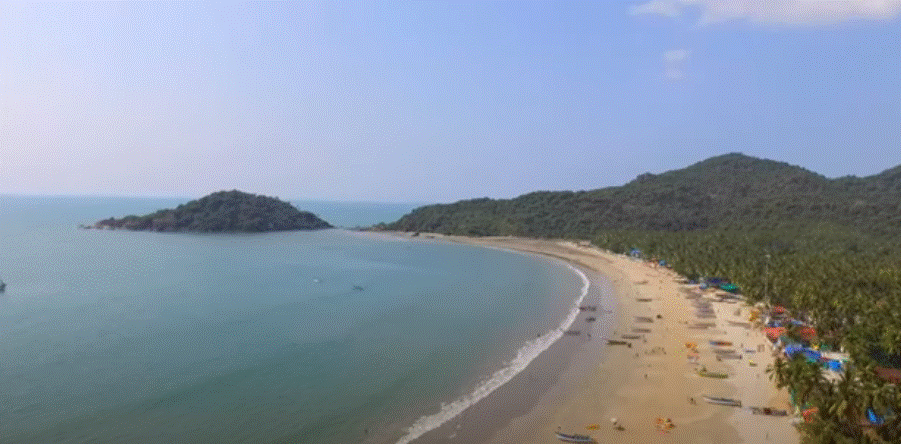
<box><xmin>594</xmin><ymin>227</ymin><xmax>901</xmax><ymax>443</ymax></box>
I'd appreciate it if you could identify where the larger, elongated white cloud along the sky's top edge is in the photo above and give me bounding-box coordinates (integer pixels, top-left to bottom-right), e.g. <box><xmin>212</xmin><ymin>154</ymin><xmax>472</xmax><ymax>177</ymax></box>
<box><xmin>630</xmin><ymin>0</ymin><xmax>901</xmax><ymax>25</ymax></box>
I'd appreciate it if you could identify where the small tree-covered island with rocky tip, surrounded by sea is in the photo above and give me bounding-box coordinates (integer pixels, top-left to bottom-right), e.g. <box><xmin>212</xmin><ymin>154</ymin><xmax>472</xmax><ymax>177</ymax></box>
<box><xmin>90</xmin><ymin>190</ymin><xmax>332</xmax><ymax>233</ymax></box>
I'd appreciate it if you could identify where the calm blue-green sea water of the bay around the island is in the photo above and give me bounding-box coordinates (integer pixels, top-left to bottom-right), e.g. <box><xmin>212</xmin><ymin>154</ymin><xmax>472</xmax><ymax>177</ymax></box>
<box><xmin>0</xmin><ymin>196</ymin><xmax>581</xmax><ymax>444</ymax></box>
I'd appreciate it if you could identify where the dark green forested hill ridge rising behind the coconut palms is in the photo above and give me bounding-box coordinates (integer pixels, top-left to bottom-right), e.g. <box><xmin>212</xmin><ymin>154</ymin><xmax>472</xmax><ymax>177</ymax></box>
<box><xmin>387</xmin><ymin>153</ymin><xmax>901</xmax><ymax>238</ymax></box>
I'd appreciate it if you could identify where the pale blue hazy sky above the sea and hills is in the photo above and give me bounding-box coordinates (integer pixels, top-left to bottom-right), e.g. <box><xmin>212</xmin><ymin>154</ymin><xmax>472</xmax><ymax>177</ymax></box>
<box><xmin>0</xmin><ymin>0</ymin><xmax>901</xmax><ymax>202</ymax></box>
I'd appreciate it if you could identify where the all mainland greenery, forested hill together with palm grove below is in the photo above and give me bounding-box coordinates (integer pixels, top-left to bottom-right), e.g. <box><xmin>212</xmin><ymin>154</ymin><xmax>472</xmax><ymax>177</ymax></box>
<box><xmin>383</xmin><ymin>154</ymin><xmax>901</xmax><ymax>443</ymax></box>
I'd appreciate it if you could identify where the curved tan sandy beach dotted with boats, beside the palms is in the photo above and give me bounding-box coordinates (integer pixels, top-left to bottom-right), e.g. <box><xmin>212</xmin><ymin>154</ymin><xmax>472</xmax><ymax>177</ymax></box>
<box><xmin>402</xmin><ymin>235</ymin><xmax>799</xmax><ymax>444</ymax></box>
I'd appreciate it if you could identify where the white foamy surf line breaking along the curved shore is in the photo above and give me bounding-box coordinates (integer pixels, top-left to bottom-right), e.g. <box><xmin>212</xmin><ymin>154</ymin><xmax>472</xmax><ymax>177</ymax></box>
<box><xmin>397</xmin><ymin>259</ymin><xmax>591</xmax><ymax>444</ymax></box>
